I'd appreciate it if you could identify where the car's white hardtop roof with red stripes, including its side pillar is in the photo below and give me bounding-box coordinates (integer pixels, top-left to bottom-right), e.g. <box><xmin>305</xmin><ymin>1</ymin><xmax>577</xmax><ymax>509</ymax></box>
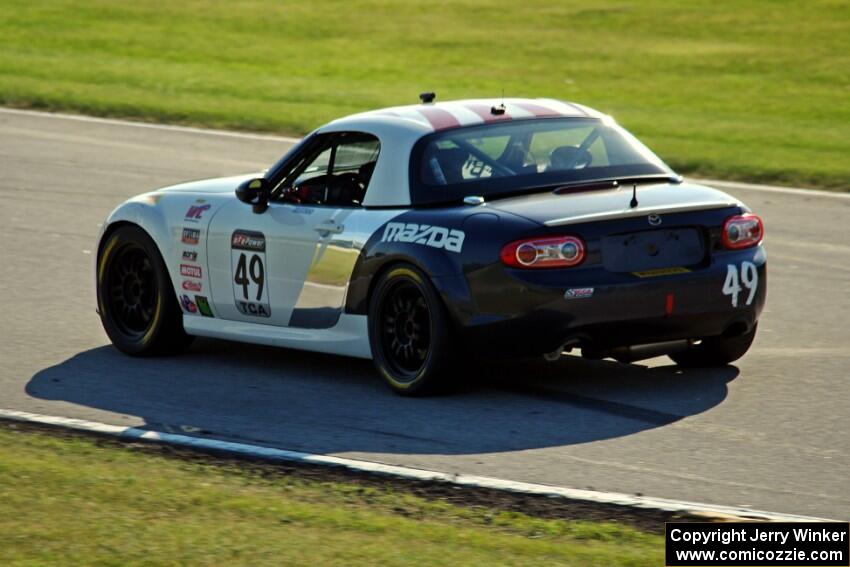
<box><xmin>316</xmin><ymin>98</ymin><xmax>605</xmax><ymax>207</ymax></box>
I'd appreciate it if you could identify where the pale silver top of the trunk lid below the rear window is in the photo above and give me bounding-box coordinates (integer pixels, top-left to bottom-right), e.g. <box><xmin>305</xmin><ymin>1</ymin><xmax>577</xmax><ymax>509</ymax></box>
<box><xmin>488</xmin><ymin>183</ymin><xmax>743</xmax><ymax>226</ymax></box>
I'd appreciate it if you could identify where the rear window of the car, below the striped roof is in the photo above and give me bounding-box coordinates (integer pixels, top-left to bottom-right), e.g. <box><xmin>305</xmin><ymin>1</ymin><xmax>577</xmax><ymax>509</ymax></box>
<box><xmin>410</xmin><ymin>118</ymin><xmax>676</xmax><ymax>204</ymax></box>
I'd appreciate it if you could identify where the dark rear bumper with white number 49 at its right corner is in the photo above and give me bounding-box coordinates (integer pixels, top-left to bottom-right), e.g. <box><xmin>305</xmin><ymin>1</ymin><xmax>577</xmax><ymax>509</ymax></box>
<box><xmin>435</xmin><ymin>246</ymin><xmax>767</xmax><ymax>356</ymax></box>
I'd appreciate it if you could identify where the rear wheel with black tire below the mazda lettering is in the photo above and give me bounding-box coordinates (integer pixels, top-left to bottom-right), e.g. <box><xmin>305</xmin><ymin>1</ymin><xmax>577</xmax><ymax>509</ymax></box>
<box><xmin>369</xmin><ymin>264</ymin><xmax>455</xmax><ymax>396</ymax></box>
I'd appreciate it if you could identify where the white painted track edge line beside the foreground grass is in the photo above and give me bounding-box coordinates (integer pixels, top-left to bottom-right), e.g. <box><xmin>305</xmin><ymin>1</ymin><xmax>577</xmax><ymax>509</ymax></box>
<box><xmin>0</xmin><ymin>409</ymin><xmax>823</xmax><ymax>522</ymax></box>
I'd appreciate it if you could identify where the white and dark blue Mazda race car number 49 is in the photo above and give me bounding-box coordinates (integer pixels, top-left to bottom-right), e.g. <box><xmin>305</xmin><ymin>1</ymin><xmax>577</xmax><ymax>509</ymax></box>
<box><xmin>96</xmin><ymin>93</ymin><xmax>766</xmax><ymax>395</ymax></box>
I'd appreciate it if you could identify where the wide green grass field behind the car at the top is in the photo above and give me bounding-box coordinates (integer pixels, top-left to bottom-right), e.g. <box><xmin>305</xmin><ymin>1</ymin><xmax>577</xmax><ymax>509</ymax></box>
<box><xmin>0</xmin><ymin>0</ymin><xmax>850</xmax><ymax>190</ymax></box>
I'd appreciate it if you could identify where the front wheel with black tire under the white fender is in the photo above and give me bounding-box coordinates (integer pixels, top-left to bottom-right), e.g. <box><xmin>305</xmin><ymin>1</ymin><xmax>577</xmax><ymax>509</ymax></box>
<box><xmin>97</xmin><ymin>225</ymin><xmax>194</xmax><ymax>356</ymax></box>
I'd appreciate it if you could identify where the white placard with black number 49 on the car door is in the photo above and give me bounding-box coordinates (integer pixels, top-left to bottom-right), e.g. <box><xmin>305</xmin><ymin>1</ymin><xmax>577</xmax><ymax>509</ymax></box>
<box><xmin>230</xmin><ymin>230</ymin><xmax>272</xmax><ymax>317</ymax></box>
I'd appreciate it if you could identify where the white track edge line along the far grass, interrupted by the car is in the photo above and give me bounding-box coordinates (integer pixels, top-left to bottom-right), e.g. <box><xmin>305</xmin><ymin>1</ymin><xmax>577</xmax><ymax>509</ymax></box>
<box><xmin>0</xmin><ymin>107</ymin><xmax>850</xmax><ymax>199</ymax></box>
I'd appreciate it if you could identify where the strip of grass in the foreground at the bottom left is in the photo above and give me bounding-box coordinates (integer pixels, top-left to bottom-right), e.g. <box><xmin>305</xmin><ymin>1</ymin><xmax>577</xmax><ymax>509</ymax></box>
<box><xmin>0</xmin><ymin>427</ymin><xmax>663</xmax><ymax>567</ymax></box>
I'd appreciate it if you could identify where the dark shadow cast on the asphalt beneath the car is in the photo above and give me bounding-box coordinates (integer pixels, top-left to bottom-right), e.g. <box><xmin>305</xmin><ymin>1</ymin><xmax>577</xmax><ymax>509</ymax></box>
<box><xmin>26</xmin><ymin>339</ymin><xmax>738</xmax><ymax>454</ymax></box>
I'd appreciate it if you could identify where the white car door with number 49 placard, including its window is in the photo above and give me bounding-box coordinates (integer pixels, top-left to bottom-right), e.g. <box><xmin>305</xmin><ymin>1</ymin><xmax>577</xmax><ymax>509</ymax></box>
<box><xmin>207</xmin><ymin>132</ymin><xmax>380</xmax><ymax>329</ymax></box>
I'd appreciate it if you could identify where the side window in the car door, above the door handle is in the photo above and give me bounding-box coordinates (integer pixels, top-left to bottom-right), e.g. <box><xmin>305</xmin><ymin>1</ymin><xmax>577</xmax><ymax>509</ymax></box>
<box><xmin>275</xmin><ymin>132</ymin><xmax>381</xmax><ymax>207</ymax></box>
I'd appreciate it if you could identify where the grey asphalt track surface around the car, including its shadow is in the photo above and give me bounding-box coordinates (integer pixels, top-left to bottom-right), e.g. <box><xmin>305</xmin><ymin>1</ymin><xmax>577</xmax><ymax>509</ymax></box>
<box><xmin>0</xmin><ymin>111</ymin><xmax>850</xmax><ymax>520</ymax></box>
